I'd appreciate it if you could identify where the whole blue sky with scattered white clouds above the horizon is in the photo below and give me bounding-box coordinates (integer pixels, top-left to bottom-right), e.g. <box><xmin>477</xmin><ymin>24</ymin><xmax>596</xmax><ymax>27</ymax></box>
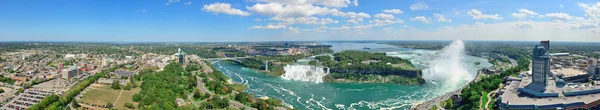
<box><xmin>0</xmin><ymin>0</ymin><xmax>600</xmax><ymax>42</ymax></box>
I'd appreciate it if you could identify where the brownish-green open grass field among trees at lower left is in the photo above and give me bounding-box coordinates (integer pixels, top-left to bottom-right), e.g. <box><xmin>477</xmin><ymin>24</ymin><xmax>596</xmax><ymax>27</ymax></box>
<box><xmin>78</xmin><ymin>81</ymin><xmax>141</xmax><ymax>110</ymax></box>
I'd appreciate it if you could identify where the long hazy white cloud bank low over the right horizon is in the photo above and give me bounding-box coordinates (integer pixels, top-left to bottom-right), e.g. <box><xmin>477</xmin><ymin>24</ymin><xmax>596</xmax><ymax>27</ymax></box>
<box><xmin>390</xmin><ymin>22</ymin><xmax>600</xmax><ymax>41</ymax></box>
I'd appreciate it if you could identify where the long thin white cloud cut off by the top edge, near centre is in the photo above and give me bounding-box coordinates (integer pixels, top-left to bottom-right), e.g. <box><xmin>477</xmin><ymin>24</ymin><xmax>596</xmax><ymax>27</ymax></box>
<box><xmin>257</xmin><ymin>0</ymin><xmax>358</xmax><ymax>8</ymax></box>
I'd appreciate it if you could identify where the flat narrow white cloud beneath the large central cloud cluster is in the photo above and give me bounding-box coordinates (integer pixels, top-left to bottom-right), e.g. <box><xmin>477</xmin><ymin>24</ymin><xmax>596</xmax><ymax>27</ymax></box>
<box><xmin>269</xmin><ymin>17</ymin><xmax>339</xmax><ymax>25</ymax></box>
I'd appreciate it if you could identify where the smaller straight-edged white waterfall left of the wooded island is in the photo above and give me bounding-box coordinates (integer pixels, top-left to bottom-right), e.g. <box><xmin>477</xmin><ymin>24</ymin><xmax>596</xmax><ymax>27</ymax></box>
<box><xmin>281</xmin><ymin>65</ymin><xmax>328</xmax><ymax>83</ymax></box>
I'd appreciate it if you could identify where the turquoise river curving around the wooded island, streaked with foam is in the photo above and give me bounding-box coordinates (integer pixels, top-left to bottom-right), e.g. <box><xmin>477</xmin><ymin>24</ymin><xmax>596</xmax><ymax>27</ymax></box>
<box><xmin>214</xmin><ymin>41</ymin><xmax>492</xmax><ymax>110</ymax></box>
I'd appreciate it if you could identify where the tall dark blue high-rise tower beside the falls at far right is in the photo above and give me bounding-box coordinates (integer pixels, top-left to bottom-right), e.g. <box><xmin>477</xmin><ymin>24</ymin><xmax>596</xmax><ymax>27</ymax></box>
<box><xmin>531</xmin><ymin>45</ymin><xmax>550</xmax><ymax>86</ymax></box>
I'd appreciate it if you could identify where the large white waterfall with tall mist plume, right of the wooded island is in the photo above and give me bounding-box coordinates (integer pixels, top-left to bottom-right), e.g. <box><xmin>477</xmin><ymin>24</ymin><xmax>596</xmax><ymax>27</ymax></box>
<box><xmin>423</xmin><ymin>40</ymin><xmax>474</xmax><ymax>85</ymax></box>
